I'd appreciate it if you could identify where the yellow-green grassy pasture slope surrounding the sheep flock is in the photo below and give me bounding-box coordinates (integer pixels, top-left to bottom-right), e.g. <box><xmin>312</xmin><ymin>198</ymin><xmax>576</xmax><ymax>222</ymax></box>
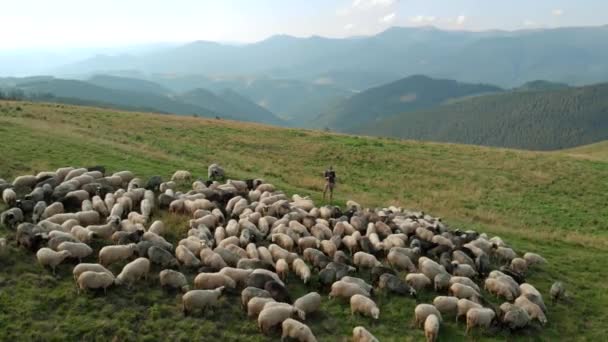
<box><xmin>0</xmin><ymin>102</ymin><xmax>608</xmax><ymax>341</ymax></box>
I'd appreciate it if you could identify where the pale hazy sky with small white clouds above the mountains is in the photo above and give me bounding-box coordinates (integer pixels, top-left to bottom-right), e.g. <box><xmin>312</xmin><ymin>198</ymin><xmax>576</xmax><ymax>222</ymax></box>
<box><xmin>0</xmin><ymin>0</ymin><xmax>608</xmax><ymax>51</ymax></box>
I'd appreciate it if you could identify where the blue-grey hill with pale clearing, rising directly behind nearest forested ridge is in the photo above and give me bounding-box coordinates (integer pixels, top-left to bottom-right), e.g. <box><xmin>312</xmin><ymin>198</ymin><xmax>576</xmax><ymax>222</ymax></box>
<box><xmin>314</xmin><ymin>76</ymin><xmax>502</xmax><ymax>132</ymax></box>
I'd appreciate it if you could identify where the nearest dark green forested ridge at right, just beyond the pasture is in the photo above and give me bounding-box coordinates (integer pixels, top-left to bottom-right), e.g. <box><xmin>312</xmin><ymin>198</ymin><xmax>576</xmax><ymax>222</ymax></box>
<box><xmin>352</xmin><ymin>84</ymin><xmax>608</xmax><ymax>150</ymax></box>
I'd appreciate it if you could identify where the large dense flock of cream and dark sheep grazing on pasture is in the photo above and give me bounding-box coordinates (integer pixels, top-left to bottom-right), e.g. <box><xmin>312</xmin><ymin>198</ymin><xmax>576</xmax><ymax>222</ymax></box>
<box><xmin>0</xmin><ymin>164</ymin><xmax>564</xmax><ymax>341</ymax></box>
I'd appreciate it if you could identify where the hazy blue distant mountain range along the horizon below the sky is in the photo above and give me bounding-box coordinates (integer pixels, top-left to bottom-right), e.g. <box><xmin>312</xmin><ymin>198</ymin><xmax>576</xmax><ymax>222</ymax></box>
<box><xmin>52</xmin><ymin>26</ymin><xmax>608</xmax><ymax>91</ymax></box>
